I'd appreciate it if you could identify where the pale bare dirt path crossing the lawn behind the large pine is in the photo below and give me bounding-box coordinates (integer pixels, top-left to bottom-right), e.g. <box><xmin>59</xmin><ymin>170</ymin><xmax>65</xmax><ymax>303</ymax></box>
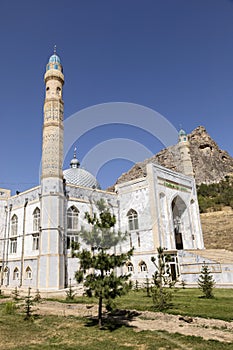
<box><xmin>36</xmin><ymin>301</ymin><xmax>233</xmax><ymax>342</ymax></box>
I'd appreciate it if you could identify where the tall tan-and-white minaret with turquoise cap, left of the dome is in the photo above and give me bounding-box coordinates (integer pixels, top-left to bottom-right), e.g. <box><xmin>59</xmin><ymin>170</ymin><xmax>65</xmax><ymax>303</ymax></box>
<box><xmin>38</xmin><ymin>50</ymin><xmax>65</xmax><ymax>290</ymax></box>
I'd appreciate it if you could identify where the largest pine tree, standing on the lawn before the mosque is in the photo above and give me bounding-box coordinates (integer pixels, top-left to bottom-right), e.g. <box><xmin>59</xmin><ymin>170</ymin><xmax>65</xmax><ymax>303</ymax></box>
<box><xmin>73</xmin><ymin>200</ymin><xmax>133</xmax><ymax>327</ymax></box>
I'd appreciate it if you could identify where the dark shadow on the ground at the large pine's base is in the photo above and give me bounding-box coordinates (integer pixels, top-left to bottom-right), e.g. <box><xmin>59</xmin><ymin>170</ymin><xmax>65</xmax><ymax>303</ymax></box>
<box><xmin>85</xmin><ymin>309</ymin><xmax>140</xmax><ymax>332</ymax></box>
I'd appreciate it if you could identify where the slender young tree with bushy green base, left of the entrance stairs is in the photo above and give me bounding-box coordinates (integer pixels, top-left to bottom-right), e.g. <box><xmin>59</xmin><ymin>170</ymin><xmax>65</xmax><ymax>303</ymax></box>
<box><xmin>151</xmin><ymin>247</ymin><xmax>176</xmax><ymax>311</ymax></box>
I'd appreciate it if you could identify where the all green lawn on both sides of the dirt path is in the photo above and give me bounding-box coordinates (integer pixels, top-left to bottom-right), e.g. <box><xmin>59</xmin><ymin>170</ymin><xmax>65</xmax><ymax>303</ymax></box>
<box><xmin>0</xmin><ymin>289</ymin><xmax>233</xmax><ymax>350</ymax></box>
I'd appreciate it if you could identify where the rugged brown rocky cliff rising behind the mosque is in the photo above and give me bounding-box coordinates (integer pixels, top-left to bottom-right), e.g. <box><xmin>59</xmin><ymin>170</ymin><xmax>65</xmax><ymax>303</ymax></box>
<box><xmin>109</xmin><ymin>126</ymin><xmax>233</xmax><ymax>190</ymax></box>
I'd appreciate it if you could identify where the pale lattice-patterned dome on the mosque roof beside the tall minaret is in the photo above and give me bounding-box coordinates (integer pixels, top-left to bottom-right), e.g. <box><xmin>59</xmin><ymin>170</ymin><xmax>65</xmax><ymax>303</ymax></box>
<box><xmin>63</xmin><ymin>168</ymin><xmax>100</xmax><ymax>189</ymax></box>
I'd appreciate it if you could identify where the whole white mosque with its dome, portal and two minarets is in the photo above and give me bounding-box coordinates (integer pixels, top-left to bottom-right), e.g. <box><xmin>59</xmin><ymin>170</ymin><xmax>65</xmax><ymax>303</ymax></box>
<box><xmin>0</xmin><ymin>53</ymin><xmax>233</xmax><ymax>291</ymax></box>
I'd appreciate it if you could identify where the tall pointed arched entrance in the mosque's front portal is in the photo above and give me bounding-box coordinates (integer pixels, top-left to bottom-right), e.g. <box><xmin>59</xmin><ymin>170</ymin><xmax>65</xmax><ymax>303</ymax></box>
<box><xmin>172</xmin><ymin>196</ymin><xmax>187</xmax><ymax>250</ymax></box>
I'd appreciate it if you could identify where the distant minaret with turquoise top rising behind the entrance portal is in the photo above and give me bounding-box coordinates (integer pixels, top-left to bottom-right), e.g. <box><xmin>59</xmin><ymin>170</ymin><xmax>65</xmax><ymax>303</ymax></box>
<box><xmin>178</xmin><ymin>129</ymin><xmax>194</xmax><ymax>176</ymax></box>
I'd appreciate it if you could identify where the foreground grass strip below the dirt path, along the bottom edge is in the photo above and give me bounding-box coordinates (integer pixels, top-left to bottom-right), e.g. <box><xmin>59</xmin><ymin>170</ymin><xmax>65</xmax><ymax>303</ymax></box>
<box><xmin>0</xmin><ymin>314</ymin><xmax>232</xmax><ymax>350</ymax></box>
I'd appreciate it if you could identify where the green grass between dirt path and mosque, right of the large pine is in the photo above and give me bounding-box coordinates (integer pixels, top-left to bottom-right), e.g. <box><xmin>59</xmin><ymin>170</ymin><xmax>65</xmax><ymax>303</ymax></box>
<box><xmin>116</xmin><ymin>288</ymin><xmax>233</xmax><ymax>321</ymax></box>
